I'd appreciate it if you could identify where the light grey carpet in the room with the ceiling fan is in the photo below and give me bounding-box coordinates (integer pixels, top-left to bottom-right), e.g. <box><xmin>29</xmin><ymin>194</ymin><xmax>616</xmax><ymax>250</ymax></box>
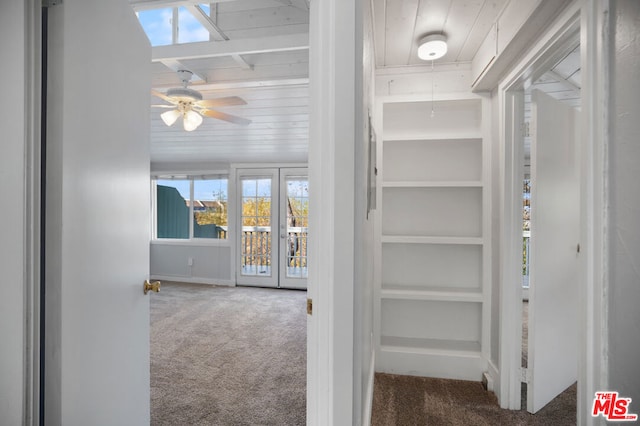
<box><xmin>151</xmin><ymin>282</ymin><xmax>307</xmax><ymax>425</ymax></box>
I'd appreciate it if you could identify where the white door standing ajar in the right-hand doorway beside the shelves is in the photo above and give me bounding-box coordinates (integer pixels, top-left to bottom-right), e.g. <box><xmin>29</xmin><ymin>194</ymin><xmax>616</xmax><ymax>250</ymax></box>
<box><xmin>527</xmin><ymin>90</ymin><xmax>580</xmax><ymax>413</ymax></box>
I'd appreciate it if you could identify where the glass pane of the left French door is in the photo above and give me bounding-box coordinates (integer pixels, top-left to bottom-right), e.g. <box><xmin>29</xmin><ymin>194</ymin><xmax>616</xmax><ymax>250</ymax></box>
<box><xmin>240</xmin><ymin>177</ymin><xmax>272</xmax><ymax>277</ymax></box>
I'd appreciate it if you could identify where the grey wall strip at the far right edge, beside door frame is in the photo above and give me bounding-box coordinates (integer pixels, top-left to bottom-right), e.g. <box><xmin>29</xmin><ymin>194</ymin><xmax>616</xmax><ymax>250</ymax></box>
<box><xmin>608</xmin><ymin>0</ymin><xmax>640</xmax><ymax>404</ymax></box>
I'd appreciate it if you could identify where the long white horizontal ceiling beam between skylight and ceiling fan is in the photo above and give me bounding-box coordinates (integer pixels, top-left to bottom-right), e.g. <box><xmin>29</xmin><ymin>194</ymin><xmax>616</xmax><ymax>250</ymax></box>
<box><xmin>151</xmin><ymin>34</ymin><xmax>309</xmax><ymax>62</ymax></box>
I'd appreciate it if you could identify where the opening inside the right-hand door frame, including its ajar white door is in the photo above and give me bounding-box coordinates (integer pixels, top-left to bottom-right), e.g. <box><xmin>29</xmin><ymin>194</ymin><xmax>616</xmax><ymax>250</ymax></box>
<box><xmin>514</xmin><ymin>33</ymin><xmax>581</xmax><ymax>413</ymax></box>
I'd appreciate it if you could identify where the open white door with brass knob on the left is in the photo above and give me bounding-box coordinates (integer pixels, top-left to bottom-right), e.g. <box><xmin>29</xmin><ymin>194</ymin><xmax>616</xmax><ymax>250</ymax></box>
<box><xmin>44</xmin><ymin>0</ymin><xmax>153</xmax><ymax>425</ymax></box>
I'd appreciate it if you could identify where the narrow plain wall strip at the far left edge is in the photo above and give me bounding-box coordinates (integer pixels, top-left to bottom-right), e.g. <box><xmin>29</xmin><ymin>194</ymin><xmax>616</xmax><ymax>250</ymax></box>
<box><xmin>0</xmin><ymin>0</ymin><xmax>31</xmax><ymax>425</ymax></box>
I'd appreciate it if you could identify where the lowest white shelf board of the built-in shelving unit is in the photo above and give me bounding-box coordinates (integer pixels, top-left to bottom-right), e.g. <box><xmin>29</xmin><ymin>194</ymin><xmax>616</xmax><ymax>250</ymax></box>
<box><xmin>380</xmin><ymin>336</ymin><xmax>480</xmax><ymax>357</ymax></box>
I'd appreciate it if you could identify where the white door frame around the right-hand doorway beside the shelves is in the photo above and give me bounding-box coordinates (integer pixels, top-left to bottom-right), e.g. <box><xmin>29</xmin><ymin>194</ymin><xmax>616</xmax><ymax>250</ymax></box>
<box><xmin>496</xmin><ymin>0</ymin><xmax>610</xmax><ymax>425</ymax></box>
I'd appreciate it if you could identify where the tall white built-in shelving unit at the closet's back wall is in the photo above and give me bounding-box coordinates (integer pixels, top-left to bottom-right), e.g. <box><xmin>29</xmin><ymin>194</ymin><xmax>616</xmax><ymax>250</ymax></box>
<box><xmin>375</xmin><ymin>94</ymin><xmax>490</xmax><ymax>380</ymax></box>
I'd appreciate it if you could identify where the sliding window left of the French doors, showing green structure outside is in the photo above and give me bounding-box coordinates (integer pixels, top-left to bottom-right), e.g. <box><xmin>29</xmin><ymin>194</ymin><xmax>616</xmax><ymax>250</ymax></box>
<box><xmin>155</xmin><ymin>176</ymin><xmax>229</xmax><ymax>240</ymax></box>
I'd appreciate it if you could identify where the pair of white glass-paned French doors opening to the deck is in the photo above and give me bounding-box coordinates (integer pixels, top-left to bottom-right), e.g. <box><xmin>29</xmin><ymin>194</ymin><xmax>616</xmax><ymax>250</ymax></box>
<box><xmin>236</xmin><ymin>168</ymin><xmax>309</xmax><ymax>289</ymax></box>
